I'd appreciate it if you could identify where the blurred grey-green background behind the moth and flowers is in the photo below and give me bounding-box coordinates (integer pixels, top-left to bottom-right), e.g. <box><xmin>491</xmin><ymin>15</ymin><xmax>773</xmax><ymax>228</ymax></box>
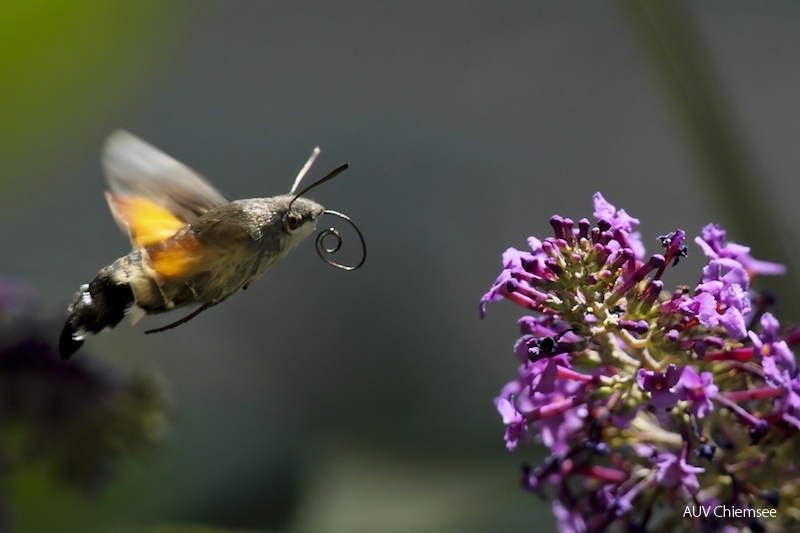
<box><xmin>0</xmin><ymin>0</ymin><xmax>800</xmax><ymax>532</ymax></box>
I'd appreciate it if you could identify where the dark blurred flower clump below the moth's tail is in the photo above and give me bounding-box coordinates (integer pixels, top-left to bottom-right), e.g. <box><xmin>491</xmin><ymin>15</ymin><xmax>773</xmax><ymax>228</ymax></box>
<box><xmin>0</xmin><ymin>279</ymin><xmax>170</xmax><ymax>525</ymax></box>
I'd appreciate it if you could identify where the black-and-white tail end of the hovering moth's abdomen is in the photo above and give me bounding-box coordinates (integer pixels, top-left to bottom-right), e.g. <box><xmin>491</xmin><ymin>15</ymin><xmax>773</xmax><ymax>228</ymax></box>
<box><xmin>58</xmin><ymin>256</ymin><xmax>134</xmax><ymax>359</ymax></box>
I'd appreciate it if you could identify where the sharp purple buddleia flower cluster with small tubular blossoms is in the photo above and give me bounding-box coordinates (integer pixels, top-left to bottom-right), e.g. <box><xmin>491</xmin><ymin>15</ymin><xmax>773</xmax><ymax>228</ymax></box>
<box><xmin>480</xmin><ymin>193</ymin><xmax>800</xmax><ymax>531</ymax></box>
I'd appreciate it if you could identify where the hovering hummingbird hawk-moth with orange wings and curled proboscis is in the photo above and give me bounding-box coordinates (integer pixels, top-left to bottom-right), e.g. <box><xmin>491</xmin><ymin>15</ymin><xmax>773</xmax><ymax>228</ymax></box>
<box><xmin>59</xmin><ymin>131</ymin><xmax>366</xmax><ymax>359</ymax></box>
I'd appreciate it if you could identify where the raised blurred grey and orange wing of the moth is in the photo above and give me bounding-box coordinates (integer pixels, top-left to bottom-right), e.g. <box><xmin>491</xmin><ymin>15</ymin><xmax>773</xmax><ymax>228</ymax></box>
<box><xmin>103</xmin><ymin>130</ymin><xmax>228</xmax><ymax>248</ymax></box>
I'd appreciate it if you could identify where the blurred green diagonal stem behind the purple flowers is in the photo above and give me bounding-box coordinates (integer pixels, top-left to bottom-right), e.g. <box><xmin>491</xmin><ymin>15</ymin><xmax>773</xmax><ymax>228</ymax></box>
<box><xmin>623</xmin><ymin>0</ymin><xmax>800</xmax><ymax>320</ymax></box>
